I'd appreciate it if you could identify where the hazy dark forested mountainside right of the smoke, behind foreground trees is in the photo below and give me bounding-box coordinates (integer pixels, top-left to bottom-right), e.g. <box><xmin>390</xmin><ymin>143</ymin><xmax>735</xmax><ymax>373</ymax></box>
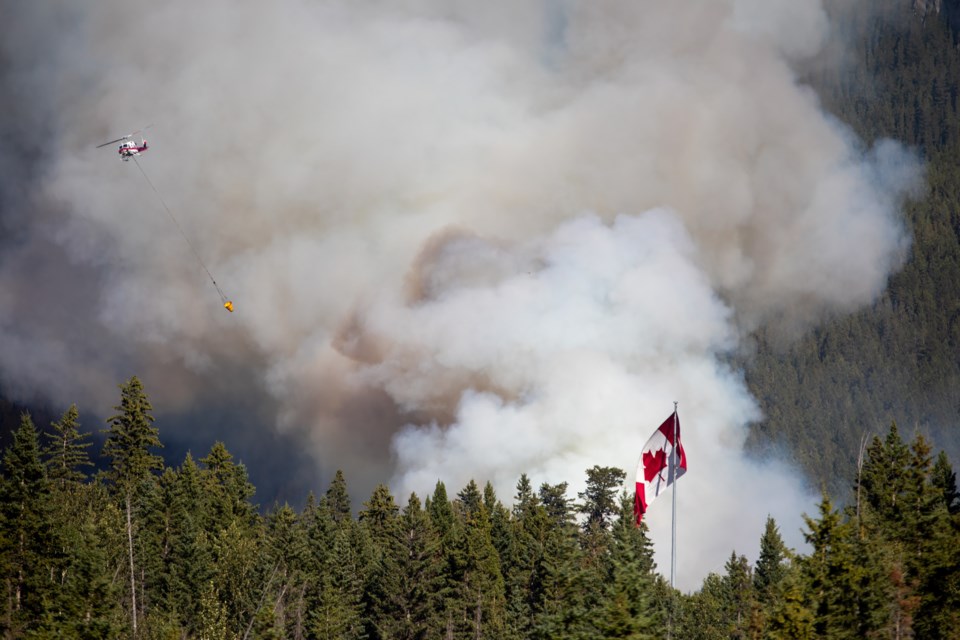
<box><xmin>746</xmin><ymin>0</ymin><xmax>960</xmax><ymax>500</ymax></box>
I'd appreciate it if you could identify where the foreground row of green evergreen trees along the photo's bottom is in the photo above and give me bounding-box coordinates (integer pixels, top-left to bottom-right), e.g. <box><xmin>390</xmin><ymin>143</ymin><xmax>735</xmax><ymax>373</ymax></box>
<box><xmin>0</xmin><ymin>378</ymin><xmax>960</xmax><ymax>640</ymax></box>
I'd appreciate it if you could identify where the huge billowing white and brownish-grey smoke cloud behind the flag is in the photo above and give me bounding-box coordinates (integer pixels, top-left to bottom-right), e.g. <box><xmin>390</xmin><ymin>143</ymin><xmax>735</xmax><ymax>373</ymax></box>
<box><xmin>0</xmin><ymin>0</ymin><xmax>917</xmax><ymax>588</ymax></box>
